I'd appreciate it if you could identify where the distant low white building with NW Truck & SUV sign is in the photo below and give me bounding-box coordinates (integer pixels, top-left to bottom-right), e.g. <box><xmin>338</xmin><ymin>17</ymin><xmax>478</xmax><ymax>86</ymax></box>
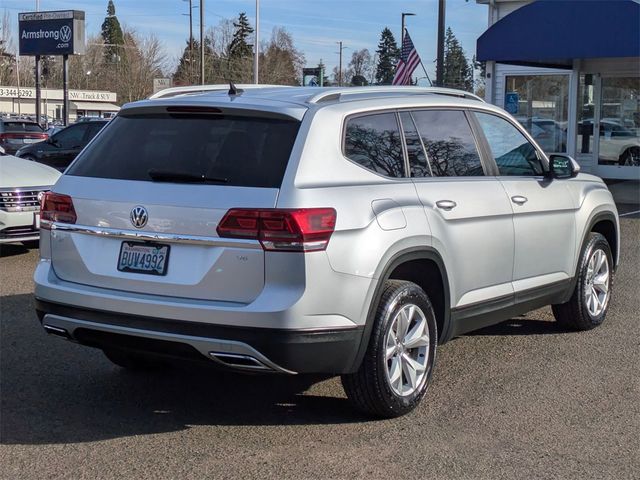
<box><xmin>0</xmin><ymin>86</ymin><xmax>120</xmax><ymax>122</ymax></box>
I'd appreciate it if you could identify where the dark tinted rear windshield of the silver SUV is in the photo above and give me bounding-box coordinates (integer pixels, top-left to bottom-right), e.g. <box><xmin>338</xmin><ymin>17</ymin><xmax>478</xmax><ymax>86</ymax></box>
<box><xmin>67</xmin><ymin>114</ymin><xmax>300</xmax><ymax>188</ymax></box>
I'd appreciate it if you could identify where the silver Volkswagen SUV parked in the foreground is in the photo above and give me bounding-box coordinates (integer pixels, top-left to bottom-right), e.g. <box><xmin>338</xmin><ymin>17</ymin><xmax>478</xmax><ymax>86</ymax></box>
<box><xmin>35</xmin><ymin>86</ymin><xmax>619</xmax><ymax>417</ymax></box>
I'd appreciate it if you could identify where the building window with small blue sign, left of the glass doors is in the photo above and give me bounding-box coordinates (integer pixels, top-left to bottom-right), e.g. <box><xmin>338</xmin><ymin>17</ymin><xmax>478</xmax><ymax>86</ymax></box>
<box><xmin>504</xmin><ymin>75</ymin><xmax>569</xmax><ymax>153</ymax></box>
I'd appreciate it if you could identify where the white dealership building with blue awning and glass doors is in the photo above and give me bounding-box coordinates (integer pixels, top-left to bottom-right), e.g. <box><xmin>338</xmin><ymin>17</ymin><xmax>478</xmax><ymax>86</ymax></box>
<box><xmin>476</xmin><ymin>0</ymin><xmax>640</xmax><ymax>181</ymax></box>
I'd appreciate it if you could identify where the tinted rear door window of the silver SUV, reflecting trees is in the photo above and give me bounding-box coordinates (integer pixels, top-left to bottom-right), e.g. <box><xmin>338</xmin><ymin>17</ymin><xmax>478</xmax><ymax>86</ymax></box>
<box><xmin>412</xmin><ymin>110</ymin><xmax>484</xmax><ymax>177</ymax></box>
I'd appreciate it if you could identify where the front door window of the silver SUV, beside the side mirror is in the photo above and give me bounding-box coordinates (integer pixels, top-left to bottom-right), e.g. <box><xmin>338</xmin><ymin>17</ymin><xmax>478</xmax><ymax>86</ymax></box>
<box><xmin>475</xmin><ymin>112</ymin><xmax>543</xmax><ymax>176</ymax></box>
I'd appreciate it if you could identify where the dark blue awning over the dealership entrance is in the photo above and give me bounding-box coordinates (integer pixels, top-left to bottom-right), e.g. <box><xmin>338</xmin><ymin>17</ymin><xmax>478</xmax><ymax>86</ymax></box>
<box><xmin>477</xmin><ymin>0</ymin><xmax>640</xmax><ymax>68</ymax></box>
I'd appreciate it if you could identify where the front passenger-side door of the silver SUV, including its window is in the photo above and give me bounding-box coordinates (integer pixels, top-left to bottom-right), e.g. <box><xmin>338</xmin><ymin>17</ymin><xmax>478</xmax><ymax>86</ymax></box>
<box><xmin>474</xmin><ymin>112</ymin><xmax>577</xmax><ymax>293</ymax></box>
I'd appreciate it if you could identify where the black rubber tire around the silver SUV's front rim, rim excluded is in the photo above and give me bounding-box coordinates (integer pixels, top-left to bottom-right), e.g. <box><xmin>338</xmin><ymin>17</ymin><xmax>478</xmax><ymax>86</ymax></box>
<box><xmin>551</xmin><ymin>232</ymin><xmax>614</xmax><ymax>330</ymax></box>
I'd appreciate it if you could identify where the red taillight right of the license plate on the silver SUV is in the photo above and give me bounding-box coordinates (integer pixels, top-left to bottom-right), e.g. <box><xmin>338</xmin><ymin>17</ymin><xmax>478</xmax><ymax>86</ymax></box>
<box><xmin>217</xmin><ymin>208</ymin><xmax>336</xmax><ymax>252</ymax></box>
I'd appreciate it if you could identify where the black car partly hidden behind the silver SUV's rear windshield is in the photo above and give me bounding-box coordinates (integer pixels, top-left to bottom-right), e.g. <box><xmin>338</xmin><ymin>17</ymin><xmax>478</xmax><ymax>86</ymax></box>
<box><xmin>16</xmin><ymin>119</ymin><xmax>109</xmax><ymax>171</ymax></box>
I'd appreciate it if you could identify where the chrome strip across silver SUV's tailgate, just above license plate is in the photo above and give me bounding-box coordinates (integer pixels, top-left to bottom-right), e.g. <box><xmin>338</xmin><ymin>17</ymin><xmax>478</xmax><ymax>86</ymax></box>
<box><xmin>46</xmin><ymin>220</ymin><xmax>262</xmax><ymax>250</ymax></box>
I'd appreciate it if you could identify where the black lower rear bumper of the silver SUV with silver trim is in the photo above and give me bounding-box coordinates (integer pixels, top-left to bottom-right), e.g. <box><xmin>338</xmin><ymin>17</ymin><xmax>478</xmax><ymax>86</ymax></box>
<box><xmin>36</xmin><ymin>300</ymin><xmax>363</xmax><ymax>374</ymax></box>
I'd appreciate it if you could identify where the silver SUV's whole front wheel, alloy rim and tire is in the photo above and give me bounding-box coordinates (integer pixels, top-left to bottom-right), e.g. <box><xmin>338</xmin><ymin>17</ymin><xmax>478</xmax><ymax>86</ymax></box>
<box><xmin>551</xmin><ymin>232</ymin><xmax>614</xmax><ymax>330</ymax></box>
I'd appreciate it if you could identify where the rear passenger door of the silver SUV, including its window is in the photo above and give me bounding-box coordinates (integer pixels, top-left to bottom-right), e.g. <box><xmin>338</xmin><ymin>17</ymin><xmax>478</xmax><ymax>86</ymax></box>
<box><xmin>400</xmin><ymin>109</ymin><xmax>513</xmax><ymax>308</ymax></box>
